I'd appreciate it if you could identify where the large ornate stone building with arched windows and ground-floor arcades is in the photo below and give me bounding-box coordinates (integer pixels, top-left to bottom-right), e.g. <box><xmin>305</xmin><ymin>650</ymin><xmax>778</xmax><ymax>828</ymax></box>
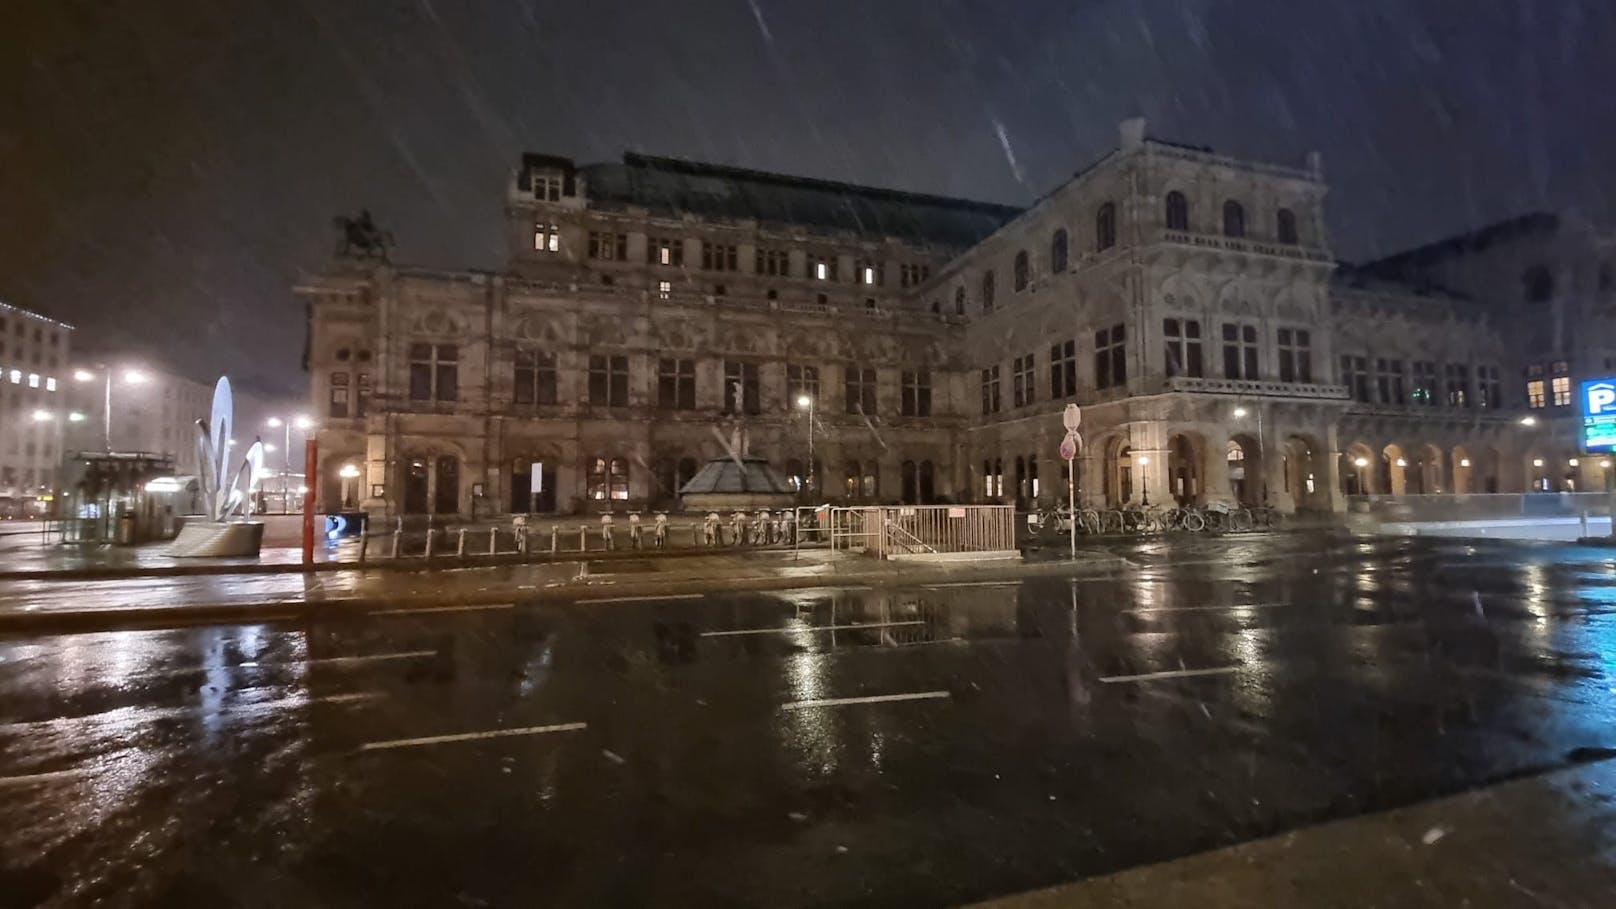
<box><xmin>297</xmin><ymin>121</ymin><xmax>1616</xmax><ymax>514</ymax></box>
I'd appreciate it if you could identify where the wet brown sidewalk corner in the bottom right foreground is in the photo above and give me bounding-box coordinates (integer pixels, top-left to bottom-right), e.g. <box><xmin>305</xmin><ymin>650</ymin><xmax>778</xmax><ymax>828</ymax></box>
<box><xmin>979</xmin><ymin>760</ymin><xmax>1616</xmax><ymax>909</ymax></box>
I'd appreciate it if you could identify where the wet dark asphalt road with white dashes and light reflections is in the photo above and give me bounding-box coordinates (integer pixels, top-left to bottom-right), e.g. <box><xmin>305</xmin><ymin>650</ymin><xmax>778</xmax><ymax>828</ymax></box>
<box><xmin>0</xmin><ymin>535</ymin><xmax>1616</xmax><ymax>906</ymax></box>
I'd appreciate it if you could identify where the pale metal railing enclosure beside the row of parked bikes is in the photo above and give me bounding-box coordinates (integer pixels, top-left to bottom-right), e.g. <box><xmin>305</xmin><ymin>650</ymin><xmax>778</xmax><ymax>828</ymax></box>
<box><xmin>831</xmin><ymin>505</ymin><xmax>1016</xmax><ymax>558</ymax></box>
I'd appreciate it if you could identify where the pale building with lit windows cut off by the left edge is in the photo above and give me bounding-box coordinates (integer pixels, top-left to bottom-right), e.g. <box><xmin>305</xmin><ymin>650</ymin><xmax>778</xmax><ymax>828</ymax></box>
<box><xmin>0</xmin><ymin>301</ymin><xmax>73</xmax><ymax>504</ymax></box>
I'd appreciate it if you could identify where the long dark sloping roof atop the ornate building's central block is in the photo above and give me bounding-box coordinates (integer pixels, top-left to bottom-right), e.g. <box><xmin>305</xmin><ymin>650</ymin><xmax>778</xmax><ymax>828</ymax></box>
<box><xmin>579</xmin><ymin>152</ymin><xmax>1021</xmax><ymax>247</ymax></box>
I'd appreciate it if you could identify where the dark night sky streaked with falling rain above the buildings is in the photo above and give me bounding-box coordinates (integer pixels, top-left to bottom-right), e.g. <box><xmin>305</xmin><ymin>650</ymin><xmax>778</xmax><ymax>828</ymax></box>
<box><xmin>0</xmin><ymin>0</ymin><xmax>1616</xmax><ymax>391</ymax></box>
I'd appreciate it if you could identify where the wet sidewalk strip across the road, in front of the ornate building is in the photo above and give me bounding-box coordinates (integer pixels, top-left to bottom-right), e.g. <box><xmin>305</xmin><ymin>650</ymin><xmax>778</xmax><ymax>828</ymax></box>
<box><xmin>0</xmin><ymin>550</ymin><xmax>1126</xmax><ymax>634</ymax></box>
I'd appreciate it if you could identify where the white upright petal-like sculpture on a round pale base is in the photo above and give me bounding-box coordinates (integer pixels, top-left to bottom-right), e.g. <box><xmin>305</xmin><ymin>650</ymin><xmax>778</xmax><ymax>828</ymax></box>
<box><xmin>168</xmin><ymin>375</ymin><xmax>263</xmax><ymax>556</ymax></box>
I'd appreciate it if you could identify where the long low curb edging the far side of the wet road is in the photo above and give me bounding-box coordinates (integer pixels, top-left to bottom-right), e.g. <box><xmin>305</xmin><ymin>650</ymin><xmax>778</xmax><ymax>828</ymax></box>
<box><xmin>0</xmin><ymin>556</ymin><xmax>1128</xmax><ymax>637</ymax></box>
